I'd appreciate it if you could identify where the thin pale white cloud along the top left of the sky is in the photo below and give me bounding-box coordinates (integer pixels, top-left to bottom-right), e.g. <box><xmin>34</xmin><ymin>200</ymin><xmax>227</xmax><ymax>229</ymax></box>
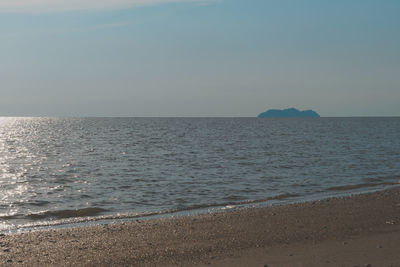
<box><xmin>0</xmin><ymin>0</ymin><xmax>210</xmax><ymax>13</ymax></box>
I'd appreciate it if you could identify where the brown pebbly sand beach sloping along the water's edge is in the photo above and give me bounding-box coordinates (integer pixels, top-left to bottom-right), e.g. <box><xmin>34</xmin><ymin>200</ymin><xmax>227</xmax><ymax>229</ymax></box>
<box><xmin>0</xmin><ymin>187</ymin><xmax>400</xmax><ymax>266</ymax></box>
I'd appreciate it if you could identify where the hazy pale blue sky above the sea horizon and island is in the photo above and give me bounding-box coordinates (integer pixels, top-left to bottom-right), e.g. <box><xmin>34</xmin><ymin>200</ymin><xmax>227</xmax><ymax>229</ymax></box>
<box><xmin>0</xmin><ymin>0</ymin><xmax>400</xmax><ymax>117</ymax></box>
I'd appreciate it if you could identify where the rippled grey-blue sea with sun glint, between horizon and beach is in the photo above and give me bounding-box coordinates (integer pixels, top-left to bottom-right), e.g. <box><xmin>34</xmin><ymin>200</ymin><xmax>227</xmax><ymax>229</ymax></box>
<box><xmin>0</xmin><ymin>118</ymin><xmax>400</xmax><ymax>230</ymax></box>
